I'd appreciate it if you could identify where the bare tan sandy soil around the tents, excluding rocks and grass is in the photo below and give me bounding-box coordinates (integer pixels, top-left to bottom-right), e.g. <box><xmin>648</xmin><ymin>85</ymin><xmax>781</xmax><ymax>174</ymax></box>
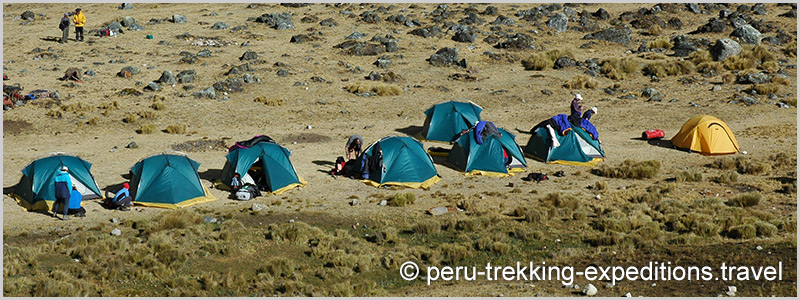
<box><xmin>2</xmin><ymin>3</ymin><xmax>797</xmax><ymax>293</ymax></box>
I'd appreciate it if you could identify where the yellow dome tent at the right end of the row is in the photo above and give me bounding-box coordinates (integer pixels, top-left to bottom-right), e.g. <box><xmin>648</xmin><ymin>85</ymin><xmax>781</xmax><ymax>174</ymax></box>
<box><xmin>672</xmin><ymin>115</ymin><xmax>739</xmax><ymax>155</ymax></box>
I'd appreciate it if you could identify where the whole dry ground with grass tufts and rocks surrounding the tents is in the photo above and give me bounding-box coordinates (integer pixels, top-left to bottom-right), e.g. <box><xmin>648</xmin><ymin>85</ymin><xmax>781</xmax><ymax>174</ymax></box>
<box><xmin>2</xmin><ymin>3</ymin><xmax>797</xmax><ymax>297</ymax></box>
